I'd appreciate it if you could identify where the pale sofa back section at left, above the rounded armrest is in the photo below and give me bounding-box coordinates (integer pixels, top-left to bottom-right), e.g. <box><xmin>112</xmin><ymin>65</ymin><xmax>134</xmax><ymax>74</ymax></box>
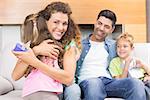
<box><xmin>0</xmin><ymin>42</ymin><xmax>24</xmax><ymax>89</ymax></box>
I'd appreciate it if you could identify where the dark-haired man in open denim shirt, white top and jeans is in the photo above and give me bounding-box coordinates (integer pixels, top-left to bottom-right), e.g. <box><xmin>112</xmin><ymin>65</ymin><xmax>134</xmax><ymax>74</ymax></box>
<box><xmin>64</xmin><ymin>10</ymin><xmax>146</xmax><ymax>100</ymax></box>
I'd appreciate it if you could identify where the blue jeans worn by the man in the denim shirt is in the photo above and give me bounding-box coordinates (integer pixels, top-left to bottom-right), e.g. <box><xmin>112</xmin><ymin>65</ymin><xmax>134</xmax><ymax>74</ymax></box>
<box><xmin>79</xmin><ymin>77</ymin><xmax>146</xmax><ymax>100</ymax></box>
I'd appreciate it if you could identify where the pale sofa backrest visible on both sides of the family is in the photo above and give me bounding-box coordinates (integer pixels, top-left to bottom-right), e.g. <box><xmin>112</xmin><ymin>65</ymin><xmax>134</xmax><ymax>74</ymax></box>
<box><xmin>0</xmin><ymin>42</ymin><xmax>150</xmax><ymax>89</ymax></box>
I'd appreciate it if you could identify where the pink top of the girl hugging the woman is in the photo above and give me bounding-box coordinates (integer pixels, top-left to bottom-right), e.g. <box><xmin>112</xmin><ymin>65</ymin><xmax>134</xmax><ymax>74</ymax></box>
<box><xmin>22</xmin><ymin>57</ymin><xmax>63</xmax><ymax>97</ymax></box>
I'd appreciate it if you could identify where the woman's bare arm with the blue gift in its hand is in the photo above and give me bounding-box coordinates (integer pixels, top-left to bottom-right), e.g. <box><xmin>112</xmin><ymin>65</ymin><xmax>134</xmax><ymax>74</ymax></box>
<box><xmin>12</xmin><ymin>47</ymin><xmax>76</xmax><ymax>85</ymax></box>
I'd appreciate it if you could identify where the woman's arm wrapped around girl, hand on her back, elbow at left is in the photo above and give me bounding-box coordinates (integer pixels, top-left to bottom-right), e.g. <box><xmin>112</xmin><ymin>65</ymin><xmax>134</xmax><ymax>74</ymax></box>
<box><xmin>12</xmin><ymin>40</ymin><xmax>60</xmax><ymax>81</ymax></box>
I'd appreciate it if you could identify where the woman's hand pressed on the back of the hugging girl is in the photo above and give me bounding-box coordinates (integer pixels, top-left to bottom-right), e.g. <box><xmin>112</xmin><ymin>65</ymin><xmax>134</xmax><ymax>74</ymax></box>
<box><xmin>33</xmin><ymin>39</ymin><xmax>61</xmax><ymax>59</ymax></box>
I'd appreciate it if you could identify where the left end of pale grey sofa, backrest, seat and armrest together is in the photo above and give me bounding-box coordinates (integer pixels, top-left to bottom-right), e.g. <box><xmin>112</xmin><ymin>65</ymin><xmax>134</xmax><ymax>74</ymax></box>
<box><xmin>0</xmin><ymin>42</ymin><xmax>24</xmax><ymax>100</ymax></box>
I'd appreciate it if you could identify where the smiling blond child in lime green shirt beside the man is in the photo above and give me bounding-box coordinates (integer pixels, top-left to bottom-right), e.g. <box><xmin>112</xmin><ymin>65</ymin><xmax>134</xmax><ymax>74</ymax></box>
<box><xmin>109</xmin><ymin>33</ymin><xmax>150</xmax><ymax>100</ymax></box>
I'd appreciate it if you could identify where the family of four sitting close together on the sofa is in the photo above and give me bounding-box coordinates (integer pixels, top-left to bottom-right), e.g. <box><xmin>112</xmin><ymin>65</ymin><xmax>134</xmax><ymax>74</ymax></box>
<box><xmin>0</xmin><ymin>2</ymin><xmax>150</xmax><ymax>100</ymax></box>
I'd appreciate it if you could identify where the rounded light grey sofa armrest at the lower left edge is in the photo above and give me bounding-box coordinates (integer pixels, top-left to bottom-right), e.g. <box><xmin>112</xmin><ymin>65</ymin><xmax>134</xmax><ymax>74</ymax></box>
<box><xmin>0</xmin><ymin>76</ymin><xmax>13</xmax><ymax>95</ymax></box>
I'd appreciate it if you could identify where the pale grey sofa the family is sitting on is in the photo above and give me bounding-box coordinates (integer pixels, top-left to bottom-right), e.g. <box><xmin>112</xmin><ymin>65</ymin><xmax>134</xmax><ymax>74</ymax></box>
<box><xmin>0</xmin><ymin>43</ymin><xmax>150</xmax><ymax>100</ymax></box>
